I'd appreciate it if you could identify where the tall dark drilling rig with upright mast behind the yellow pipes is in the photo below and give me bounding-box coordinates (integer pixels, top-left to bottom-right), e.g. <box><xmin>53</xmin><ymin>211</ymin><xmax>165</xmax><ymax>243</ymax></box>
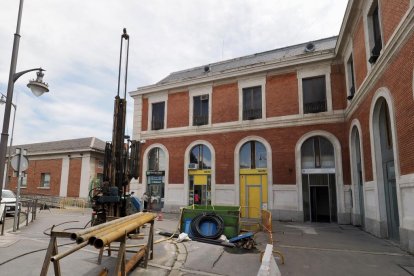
<box><xmin>89</xmin><ymin>28</ymin><xmax>140</xmax><ymax>225</ymax></box>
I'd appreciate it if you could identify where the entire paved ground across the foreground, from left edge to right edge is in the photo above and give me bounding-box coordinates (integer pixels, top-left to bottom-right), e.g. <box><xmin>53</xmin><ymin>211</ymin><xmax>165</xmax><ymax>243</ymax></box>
<box><xmin>0</xmin><ymin>209</ymin><xmax>414</xmax><ymax>276</ymax></box>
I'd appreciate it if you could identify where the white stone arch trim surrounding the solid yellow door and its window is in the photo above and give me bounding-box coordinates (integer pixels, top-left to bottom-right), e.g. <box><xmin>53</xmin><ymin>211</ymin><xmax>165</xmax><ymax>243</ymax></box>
<box><xmin>234</xmin><ymin>136</ymin><xmax>273</xmax><ymax>209</ymax></box>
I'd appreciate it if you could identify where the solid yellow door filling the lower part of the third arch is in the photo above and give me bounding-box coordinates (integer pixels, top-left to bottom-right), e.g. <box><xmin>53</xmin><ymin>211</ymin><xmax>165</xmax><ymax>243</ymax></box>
<box><xmin>240</xmin><ymin>169</ymin><xmax>267</xmax><ymax>218</ymax></box>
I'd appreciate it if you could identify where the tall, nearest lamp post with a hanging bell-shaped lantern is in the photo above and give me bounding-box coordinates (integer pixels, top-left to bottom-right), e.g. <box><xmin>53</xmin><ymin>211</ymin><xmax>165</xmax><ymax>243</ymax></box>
<box><xmin>0</xmin><ymin>0</ymin><xmax>49</xmax><ymax>201</ymax></box>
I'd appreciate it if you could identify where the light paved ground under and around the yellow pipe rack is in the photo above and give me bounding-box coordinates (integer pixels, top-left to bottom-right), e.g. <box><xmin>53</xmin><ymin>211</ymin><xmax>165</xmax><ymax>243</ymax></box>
<box><xmin>0</xmin><ymin>209</ymin><xmax>260</xmax><ymax>275</ymax></box>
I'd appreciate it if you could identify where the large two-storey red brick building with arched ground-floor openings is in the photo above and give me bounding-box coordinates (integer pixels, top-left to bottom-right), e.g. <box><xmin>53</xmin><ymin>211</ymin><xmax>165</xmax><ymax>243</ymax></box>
<box><xmin>130</xmin><ymin>0</ymin><xmax>414</xmax><ymax>252</ymax></box>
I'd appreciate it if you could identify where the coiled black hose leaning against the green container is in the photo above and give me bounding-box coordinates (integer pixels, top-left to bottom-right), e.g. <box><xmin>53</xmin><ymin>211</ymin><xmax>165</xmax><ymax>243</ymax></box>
<box><xmin>191</xmin><ymin>213</ymin><xmax>224</xmax><ymax>240</ymax></box>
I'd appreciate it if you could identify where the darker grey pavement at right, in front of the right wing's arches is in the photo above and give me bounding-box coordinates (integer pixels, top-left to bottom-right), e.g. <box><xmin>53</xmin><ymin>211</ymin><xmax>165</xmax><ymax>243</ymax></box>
<box><xmin>273</xmin><ymin>221</ymin><xmax>414</xmax><ymax>276</ymax></box>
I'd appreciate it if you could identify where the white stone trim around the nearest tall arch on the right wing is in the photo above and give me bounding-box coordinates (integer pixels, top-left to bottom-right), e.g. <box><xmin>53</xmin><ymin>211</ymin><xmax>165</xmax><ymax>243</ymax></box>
<box><xmin>369</xmin><ymin>87</ymin><xmax>403</xmax><ymax>222</ymax></box>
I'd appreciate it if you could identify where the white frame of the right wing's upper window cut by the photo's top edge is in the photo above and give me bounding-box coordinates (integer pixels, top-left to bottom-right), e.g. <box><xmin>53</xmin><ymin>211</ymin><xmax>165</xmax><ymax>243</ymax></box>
<box><xmin>363</xmin><ymin>0</ymin><xmax>384</xmax><ymax>70</ymax></box>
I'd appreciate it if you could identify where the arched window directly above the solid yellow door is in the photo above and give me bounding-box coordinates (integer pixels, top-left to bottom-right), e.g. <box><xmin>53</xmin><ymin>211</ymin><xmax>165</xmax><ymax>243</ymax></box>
<box><xmin>240</xmin><ymin>141</ymin><xmax>267</xmax><ymax>169</ymax></box>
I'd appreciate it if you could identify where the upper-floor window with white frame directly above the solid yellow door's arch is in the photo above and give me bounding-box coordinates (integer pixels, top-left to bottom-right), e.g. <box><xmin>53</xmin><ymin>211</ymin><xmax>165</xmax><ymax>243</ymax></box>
<box><xmin>238</xmin><ymin>76</ymin><xmax>266</xmax><ymax>121</ymax></box>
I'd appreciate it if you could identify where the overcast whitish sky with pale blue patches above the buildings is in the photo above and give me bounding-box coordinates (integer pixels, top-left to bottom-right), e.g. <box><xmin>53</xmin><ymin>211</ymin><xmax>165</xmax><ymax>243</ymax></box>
<box><xmin>0</xmin><ymin>0</ymin><xmax>347</xmax><ymax>144</ymax></box>
